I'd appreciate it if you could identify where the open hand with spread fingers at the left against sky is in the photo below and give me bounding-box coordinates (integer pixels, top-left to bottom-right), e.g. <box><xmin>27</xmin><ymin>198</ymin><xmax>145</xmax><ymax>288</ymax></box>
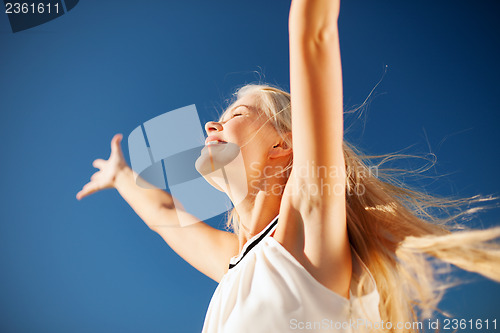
<box><xmin>76</xmin><ymin>134</ymin><xmax>127</xmax><ymax>200</ymax></box>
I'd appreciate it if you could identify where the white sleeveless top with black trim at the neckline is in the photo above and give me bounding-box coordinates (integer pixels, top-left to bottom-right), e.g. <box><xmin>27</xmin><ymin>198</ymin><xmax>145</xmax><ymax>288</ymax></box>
<box><xmin>202</xmin><ymin>216</ymin><xmax>381</xmax><ymax>333</ymax></box>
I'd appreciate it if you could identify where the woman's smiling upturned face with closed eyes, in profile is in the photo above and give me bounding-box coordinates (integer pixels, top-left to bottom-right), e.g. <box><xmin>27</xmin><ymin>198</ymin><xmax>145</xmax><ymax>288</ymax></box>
<box><xmin>196</xmin><ymin>94</ymin><xmax>282</xmax><ymax>201</ymax></box>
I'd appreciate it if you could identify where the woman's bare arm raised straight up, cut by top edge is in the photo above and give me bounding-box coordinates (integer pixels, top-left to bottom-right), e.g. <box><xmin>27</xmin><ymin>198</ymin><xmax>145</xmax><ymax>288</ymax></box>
<box><xmin>282</xmin><ymin>0</ymin><xmax>351</xmax><ymax>295</ymax></box>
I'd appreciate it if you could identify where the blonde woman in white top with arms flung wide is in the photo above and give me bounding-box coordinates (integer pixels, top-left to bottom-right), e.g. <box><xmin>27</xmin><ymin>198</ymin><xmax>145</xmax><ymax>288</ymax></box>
<box><xmin>77</xmin><ymin>0</ymin><xmax>500</xmax><ymax>332</ymax></box>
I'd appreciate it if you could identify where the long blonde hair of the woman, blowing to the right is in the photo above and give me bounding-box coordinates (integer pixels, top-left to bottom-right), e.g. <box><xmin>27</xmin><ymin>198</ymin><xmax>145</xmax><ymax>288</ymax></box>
<box><xmin>221</xmin><ymin>84</ymin><xmax>500</xmax><ymax>332</ymax></box>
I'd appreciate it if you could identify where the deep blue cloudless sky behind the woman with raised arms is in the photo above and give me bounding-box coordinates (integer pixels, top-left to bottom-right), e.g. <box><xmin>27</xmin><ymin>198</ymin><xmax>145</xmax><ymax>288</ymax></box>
<box><xmin>0</xmin><ymin>0</ymin><xmax>500</xmax><ymax>333</ymax></box>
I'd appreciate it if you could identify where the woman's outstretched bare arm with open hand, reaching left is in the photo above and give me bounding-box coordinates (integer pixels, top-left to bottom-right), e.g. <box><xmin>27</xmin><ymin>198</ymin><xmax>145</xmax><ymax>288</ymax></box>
<box><xmin>76</xmin><ymin>135</ymin><xmax>238</xmax><ymax>282</ymax></box>
